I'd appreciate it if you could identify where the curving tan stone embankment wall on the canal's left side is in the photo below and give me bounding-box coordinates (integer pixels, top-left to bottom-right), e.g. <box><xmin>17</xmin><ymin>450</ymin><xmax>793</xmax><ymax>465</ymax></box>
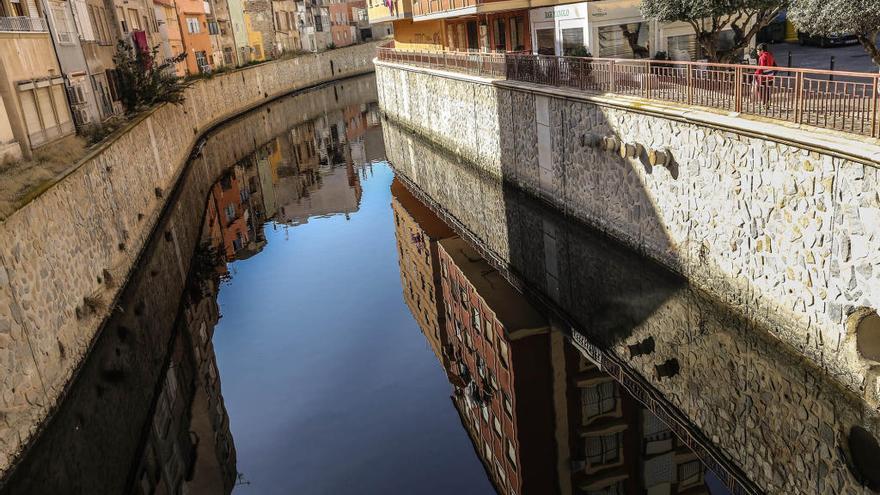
<box><xmin>0</xmin><ymin>44</ymin><xmax>375</xmax><ymax>477</ymax></box>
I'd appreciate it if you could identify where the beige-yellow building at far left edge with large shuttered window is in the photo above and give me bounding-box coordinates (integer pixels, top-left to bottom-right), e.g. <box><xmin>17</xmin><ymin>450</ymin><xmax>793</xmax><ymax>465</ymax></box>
<box><xmin>0</xmin><ymin>11</ymin><xmax>74</xmax><ymax>159</ymax></box>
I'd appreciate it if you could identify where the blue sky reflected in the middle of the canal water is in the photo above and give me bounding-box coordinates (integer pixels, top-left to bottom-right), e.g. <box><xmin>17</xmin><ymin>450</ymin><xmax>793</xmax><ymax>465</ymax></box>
<box><xmin>214</xmin><ymin>165</ymin><xmax>493</xmax><ymax>493</ymax></box>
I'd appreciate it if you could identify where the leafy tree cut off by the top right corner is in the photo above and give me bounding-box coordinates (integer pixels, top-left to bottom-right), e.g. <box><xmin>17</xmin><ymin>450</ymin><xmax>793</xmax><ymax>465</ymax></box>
<box><xmin>788</xmin><ymin>0</ymin><xmax>880</xmax><ymax>65</ymax></box>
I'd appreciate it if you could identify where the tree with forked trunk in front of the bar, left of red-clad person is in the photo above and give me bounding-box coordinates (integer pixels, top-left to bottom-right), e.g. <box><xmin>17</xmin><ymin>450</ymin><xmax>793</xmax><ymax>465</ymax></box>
<box><xmin>642</xmin><ymin>0</ymin><xmax>784</xmax><ymax>63</ymax></box>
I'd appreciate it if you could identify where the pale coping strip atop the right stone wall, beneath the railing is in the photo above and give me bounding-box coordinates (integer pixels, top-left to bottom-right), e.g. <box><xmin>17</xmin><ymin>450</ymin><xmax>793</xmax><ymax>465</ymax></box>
<box><xmin>373</xmin><ymin>59</ymin><xmax>880</xmax><ymax>168</ymax></box>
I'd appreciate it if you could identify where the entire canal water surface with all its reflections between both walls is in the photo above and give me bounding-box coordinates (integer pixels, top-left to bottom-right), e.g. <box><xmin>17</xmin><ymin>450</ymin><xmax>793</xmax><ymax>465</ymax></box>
<box><xmin>0</xmin><ymin>77</ymin><xmax>880</xmax><ymax>495</ymax></box>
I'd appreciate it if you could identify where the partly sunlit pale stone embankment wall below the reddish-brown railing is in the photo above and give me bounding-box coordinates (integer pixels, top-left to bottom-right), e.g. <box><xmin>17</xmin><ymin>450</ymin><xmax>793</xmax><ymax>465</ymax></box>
<box><xmin>376</xmin><ymin>63</ymin><xmax>880</xmax><ymax>405</ymax></box>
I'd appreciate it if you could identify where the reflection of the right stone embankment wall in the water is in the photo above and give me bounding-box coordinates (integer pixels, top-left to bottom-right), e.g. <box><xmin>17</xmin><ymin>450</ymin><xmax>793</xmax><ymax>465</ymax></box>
<box><xmin>383</xmin><ymin>123</ymin><xmax>880</xmax><ymax>494</ymax></box>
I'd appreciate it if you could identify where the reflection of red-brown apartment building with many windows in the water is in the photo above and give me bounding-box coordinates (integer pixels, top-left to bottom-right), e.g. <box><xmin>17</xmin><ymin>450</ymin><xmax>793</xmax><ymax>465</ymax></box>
<box><xmin>392</xmin><ymin>179</ymin><xmax>727</xmax><ymax>495</ymax></box>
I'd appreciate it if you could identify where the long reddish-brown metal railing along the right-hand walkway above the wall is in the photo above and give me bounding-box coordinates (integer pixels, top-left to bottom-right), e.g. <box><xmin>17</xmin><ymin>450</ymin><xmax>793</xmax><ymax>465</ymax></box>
<box><xmin>379</xmin><ymin>48</ymin><xmax>880</xmax><ymax>137</ymax></box>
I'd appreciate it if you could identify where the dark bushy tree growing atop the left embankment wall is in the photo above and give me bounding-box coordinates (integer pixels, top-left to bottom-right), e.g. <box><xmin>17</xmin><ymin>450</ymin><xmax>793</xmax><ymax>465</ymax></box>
<box><xmin>113</xmin><ymin>41</ymin><xmax>187</xmax><ymax>114</ymax></box>
